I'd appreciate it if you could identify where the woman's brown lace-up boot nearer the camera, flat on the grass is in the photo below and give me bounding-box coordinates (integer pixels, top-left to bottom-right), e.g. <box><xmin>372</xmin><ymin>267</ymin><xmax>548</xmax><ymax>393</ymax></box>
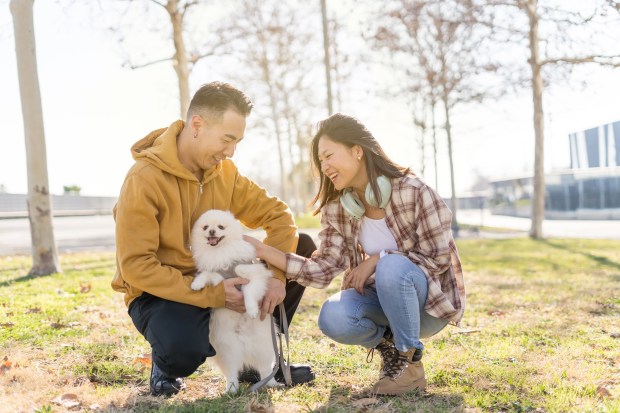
<box><xmin>372</xmin><ymin>348</ymin><xmax>426</xmax><ymax>395</ymax></box>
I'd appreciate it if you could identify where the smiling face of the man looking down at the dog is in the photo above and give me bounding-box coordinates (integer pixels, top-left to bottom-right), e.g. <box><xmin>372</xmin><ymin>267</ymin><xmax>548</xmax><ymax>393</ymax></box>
<box><xmin>194</xmin><ymin>109</ymin><xmax>245</xmax><ymax>170</ymax></box>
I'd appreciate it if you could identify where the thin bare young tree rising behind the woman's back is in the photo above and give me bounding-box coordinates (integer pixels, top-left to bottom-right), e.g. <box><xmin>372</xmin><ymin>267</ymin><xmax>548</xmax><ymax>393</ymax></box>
<box><xmin>373</xmin><ymin>0</ymin><xmax>493</xmax><ymax>230</ymax></box>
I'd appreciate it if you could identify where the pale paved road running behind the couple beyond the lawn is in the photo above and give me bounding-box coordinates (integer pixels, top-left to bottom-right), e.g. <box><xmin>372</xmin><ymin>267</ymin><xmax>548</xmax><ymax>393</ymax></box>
<box><xmin>0</xmin><ymin>210</ymin><xmax>620</xmax><ymax>256</ymax></box>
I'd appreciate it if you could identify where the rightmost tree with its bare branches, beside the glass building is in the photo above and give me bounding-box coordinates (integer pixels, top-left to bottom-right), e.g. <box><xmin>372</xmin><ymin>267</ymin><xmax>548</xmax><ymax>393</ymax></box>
<box><xmin>478</xmin><ymin>0</ymin><xmax>620</xmax><ymax>239</ymax></box>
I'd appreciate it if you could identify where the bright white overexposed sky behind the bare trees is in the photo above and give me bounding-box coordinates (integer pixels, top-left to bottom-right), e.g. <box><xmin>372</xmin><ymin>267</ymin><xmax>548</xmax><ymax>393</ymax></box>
<box><xmin>0</xmin><ymin>0</ymin><xmax>620</xmax><ymax>197</ymax></box>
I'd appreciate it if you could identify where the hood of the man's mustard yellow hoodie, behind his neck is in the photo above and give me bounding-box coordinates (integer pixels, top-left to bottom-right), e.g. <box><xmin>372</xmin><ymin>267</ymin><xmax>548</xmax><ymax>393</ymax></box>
<box><xmin>131</xmin><ymin>120</ymin><xmax>221</xmax><ymax>183</ymax></box>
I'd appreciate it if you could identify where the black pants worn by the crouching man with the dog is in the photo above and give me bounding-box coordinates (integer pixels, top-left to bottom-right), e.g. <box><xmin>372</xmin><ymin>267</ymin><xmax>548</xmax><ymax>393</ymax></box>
<box><xmin>129</xmin><ymin>234</ymin><xmax>316</xmax><ymax>377</ymax></box>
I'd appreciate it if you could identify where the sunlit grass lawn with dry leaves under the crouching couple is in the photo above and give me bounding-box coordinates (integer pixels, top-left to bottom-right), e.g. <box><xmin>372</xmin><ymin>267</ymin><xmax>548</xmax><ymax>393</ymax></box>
<box><xmin>0</xmin><ymin>238</ymin><xmax>620</xmax><ymax>413</ymax></box>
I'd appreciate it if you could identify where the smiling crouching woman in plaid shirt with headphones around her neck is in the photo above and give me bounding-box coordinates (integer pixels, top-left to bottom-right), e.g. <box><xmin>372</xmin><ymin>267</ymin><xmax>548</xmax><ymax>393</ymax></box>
<box><xmin>246</xmin><ymin>114</ymin><xmax>465</xmax><ymax>395</ymax></box>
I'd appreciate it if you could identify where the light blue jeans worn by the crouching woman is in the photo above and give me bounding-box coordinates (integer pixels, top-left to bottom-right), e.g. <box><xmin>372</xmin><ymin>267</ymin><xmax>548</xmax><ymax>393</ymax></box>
<box><xmin>319</xmin><ymin>254</ymin><xmax>448</xmax><ymax>351</ymax></box>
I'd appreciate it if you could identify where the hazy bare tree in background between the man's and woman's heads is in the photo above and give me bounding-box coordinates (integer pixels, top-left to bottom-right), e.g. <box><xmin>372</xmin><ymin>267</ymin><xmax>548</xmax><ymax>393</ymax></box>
<box><xmin>219</xmin><ymin>0</ymin><xmax>325</xmax><ymax>208</ymax></box>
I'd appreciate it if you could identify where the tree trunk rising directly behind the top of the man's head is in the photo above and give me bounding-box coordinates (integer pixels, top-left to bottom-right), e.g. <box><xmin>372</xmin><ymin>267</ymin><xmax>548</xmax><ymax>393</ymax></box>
<box><xmin>166</xmin><ymin>0</ymin><xmax>191</xmax><ymax>119</ymax></box>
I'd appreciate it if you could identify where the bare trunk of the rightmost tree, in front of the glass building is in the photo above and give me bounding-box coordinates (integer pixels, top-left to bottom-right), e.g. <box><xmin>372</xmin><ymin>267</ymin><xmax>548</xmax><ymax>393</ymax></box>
<box><xmin>526</xmin><ymin>0</ymin><xmax>545</xmax><ymax>239</ymax></box>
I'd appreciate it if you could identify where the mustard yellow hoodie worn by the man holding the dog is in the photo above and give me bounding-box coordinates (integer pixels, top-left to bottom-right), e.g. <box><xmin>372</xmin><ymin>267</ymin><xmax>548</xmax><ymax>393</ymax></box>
<box><xmin>112</xmin><ymin>120</ymin><xmax>298</xmax><ymax>308</ymax></box>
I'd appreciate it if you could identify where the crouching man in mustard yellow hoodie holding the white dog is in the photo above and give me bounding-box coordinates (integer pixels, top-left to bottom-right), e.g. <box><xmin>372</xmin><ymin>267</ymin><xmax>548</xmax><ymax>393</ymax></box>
<box><xmin>112</xmin><ymin>82</ymin><xmax>316</xmax><ymax>396</ymax></box>
